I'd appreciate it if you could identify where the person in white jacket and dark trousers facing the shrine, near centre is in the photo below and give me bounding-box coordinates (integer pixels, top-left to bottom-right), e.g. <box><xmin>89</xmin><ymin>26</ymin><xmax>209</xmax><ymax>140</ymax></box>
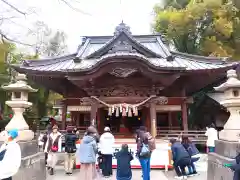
<box><xmin>99</xmin><ymin>127</ymin><xmax>115</xmax><ymax>177</ymax></box>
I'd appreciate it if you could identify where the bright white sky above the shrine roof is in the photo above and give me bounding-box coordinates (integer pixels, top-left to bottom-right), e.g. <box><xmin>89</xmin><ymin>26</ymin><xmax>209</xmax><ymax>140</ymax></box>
<box><xmin>0</xmin><ymin>0</ymin><xmax>161</xmax><ymax>52</ymax></box>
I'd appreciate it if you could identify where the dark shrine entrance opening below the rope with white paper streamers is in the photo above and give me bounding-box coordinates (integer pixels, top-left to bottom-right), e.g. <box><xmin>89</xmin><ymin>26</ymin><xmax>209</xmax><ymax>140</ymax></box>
<box><xmin>100</xmin><ymin>108</ymin><xmax>146</xmax><ymax>135</ymax></box>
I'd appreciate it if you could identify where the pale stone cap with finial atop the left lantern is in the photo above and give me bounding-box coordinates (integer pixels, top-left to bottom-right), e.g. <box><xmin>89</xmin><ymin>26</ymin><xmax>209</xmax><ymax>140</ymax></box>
<box><xmin>2</xmin><ymin>74</ymin><xmax>37</xmax><ymax>92</ymax></box>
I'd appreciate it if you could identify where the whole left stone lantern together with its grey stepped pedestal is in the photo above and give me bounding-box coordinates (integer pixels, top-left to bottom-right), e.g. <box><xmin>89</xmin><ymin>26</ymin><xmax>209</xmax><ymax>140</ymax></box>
<box><xmin>0</xmin><ymin>74</ymin><xmax>46</xmax><ymax>180</ymax></box>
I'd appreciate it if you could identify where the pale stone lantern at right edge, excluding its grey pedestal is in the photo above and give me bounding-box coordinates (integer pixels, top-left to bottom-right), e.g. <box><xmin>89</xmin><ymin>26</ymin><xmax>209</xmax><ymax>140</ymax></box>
<box><xmin>215</xmin><ymin>70</ymin><xmax>240</xmax><ymax>141</ymax></box>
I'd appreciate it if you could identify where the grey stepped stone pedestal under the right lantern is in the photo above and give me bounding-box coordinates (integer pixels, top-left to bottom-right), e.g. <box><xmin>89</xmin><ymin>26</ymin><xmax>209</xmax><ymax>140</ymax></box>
<box><xmin>207</xmin><ymin>140</ymin><xmax>240</xmax><ymax>180</ymax></box>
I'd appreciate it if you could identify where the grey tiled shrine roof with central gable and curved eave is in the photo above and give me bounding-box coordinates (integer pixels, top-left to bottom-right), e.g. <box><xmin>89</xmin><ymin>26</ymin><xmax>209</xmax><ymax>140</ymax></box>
<box><xmin>13</xmin><ymin>22</ymin><xmax>238</xmax><ymax>73</ymax></box>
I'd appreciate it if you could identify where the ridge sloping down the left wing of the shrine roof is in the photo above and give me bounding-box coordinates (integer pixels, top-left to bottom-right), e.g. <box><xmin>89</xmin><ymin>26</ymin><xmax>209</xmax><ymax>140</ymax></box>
<box><xmin>22</xmin><ymin>53</ymin><xmax>77</xmax><ymax>67</ymax></box>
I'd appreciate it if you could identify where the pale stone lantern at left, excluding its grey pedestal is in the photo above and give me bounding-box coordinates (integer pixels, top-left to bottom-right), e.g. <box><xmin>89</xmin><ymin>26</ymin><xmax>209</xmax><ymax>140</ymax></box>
<box><xmin>2</xmin><ymin>73</ymin><xmax>37</xmax><ymax>141</ymax></box>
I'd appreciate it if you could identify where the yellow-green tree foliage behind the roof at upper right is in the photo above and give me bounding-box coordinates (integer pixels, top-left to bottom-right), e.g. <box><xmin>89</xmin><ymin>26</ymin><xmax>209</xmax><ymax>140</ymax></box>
<box><xmin>153</xmin><ymin>0</ymin><xmax>240</xmax><ymax>58</ymax></box>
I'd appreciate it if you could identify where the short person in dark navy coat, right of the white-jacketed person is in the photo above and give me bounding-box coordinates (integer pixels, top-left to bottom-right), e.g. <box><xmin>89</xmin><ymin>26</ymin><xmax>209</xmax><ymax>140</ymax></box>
<box><xmin>116</xmin><ymin>144</ymin><xmax>133</xmax><ymax>180</ymax></box>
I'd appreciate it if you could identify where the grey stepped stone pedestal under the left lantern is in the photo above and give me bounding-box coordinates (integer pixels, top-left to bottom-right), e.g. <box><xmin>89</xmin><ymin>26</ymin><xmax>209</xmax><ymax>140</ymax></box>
<box><xmin>0</xmin><ymin>140</ymin><xmax>46</xmax><ymax>180</ymax></box>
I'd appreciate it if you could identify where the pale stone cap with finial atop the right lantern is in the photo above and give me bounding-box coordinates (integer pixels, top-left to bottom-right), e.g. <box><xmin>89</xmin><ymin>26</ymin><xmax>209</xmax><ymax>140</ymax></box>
<box><xmin>214</xmin><ymin>69</ymin><xmax>240</xmax><ymax>91</ymax></box>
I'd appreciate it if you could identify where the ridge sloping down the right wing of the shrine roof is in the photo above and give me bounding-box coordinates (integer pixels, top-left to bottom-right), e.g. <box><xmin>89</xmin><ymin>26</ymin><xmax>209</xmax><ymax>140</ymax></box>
<box><xmin>170</xmin><ymin>51</ymin><xmax>232</xmax><ymax>64</ymax></box>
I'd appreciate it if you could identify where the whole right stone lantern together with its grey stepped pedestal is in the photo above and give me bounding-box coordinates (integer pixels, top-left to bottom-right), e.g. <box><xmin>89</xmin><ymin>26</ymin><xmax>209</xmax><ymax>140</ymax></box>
<box><xmin>207</xmin><ymin>70</ymin><xmax>240</xmax><ymax>180</ymax></box>
